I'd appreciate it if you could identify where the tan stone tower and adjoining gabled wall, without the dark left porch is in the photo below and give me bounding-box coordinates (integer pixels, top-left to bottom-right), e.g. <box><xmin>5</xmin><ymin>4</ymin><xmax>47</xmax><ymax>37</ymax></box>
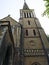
<box><xmin>1</xmin><ymin>2</ymin><xmax>49</xmax><ymax>65</ymax></box>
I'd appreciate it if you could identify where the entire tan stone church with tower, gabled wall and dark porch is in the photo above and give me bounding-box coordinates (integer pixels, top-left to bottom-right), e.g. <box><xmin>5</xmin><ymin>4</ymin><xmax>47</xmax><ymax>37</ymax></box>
<box><xmin>0</xmin><ymin>1</ymin><xmax>49</xmax><ymax>65</ymax></box>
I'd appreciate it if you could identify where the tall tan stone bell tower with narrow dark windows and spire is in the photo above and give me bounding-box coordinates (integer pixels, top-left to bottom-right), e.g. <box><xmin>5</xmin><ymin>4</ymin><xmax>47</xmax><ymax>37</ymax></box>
<box><xmin>19</xmin><ymin>2</ymin><xmax>49</xmax><ymax>65</ymax></box>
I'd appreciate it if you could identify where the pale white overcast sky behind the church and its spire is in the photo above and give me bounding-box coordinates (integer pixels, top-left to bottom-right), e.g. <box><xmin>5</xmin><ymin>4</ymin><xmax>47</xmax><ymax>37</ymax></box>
<box><xmin>0</xmin><ymin>0</ymin><xmax>49</xmax><ymax>34</ymax></box>
